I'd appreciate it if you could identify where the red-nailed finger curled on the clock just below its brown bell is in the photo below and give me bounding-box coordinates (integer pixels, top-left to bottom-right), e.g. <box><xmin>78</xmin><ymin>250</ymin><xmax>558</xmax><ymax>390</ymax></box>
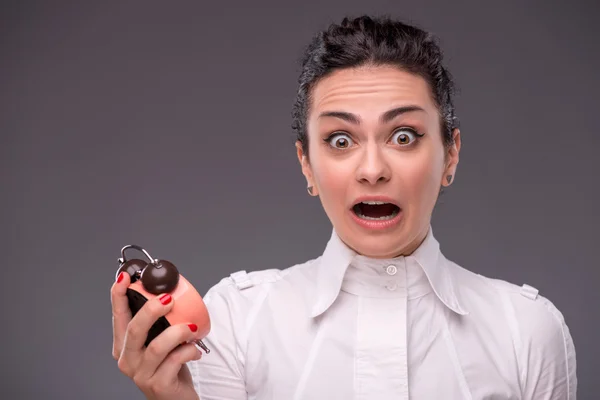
<box><xmin>122</xmin><ymin>293</ymin><xmax>174</xmax><ymax>359</ymax></box>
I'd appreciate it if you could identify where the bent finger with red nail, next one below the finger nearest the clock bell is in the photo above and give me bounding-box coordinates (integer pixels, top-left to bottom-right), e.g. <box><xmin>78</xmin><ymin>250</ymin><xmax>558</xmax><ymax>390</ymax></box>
<box><xmin>139</xmin><ymin>324</ymin><xmax>198</xmax><ymax>380</ymax></box>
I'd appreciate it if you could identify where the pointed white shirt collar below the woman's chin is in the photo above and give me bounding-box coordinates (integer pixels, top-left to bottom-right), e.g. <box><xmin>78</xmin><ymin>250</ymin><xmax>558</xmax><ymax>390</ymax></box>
<box><xmin>311</xmin><ymin>226</ymin><xmax>468</xmax><ymax>317</ymax></box>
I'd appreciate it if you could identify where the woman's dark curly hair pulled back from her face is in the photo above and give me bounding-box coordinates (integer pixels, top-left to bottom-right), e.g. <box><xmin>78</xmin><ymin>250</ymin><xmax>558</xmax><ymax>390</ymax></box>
<box><xmin>292</xmin><ymin>16</ymin><xmax>458</xmax><ymax>159</ymax></box>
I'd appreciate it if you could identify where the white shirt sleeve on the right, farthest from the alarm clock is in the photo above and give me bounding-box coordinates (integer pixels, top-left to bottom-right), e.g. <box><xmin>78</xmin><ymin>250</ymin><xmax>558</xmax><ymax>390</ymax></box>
<box><xmin>515</xmin><ymin>296</ymin><xmax>577</xmax><ymax>400</ymax></box>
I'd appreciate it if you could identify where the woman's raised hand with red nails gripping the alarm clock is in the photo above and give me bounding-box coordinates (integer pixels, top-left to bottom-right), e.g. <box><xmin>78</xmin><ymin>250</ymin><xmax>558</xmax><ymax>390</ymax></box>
<box><xmin>110</xmin><ymin>273</ymin><xmax>202</xmax><ymax>400</ymax></box>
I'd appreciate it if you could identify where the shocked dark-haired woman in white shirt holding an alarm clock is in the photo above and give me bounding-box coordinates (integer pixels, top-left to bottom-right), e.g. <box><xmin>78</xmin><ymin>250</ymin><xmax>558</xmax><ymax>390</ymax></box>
<box><xmin>112</xmin><ymin>17</ymin><xmax>577</xmax><ymax>400</ymax></box>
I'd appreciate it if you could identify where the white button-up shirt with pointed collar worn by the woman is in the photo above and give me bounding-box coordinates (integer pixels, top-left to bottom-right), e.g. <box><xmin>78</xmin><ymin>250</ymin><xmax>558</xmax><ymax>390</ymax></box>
<box><xmin>188</xmin><ymin>227</ymin><xmax>577</xmax><ymax>400</ymax></box>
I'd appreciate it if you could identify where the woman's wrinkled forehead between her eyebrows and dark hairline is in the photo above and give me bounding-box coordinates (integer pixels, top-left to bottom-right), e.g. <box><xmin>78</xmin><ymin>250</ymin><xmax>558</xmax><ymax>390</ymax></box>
<box><xmin>311</xmin><ymin>66</ymin><xmax>436</xmax><ymax>114</ymax></box>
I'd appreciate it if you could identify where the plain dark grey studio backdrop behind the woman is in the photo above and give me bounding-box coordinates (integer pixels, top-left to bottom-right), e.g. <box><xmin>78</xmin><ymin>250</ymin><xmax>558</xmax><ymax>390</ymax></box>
<box><xmin>0</xmin><ymin>0</ymin><xmax>600</xmax><ymax>399</ymax></box>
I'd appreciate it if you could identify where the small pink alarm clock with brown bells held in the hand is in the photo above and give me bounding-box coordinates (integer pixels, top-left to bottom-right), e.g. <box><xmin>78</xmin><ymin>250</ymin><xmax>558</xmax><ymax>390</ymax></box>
<box><xmin>117</xmin><ymin>245</ymin><xmax>210</xmax><ymax>354</ymax></box>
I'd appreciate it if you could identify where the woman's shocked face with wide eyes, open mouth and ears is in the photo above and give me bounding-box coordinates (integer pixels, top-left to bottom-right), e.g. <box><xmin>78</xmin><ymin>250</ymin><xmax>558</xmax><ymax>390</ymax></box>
<box><xmin>296</xmin><ymin>66</ymin><xmax>460</xmax><ymax>258</ymax></box>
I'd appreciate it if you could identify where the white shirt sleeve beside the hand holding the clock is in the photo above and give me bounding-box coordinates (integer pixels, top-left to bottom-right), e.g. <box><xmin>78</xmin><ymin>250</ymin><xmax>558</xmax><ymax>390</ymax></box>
<box><xmin>187</xmin><ymin>278</ymin><xmax>248</xmax><ymax>400</ymax></box>
